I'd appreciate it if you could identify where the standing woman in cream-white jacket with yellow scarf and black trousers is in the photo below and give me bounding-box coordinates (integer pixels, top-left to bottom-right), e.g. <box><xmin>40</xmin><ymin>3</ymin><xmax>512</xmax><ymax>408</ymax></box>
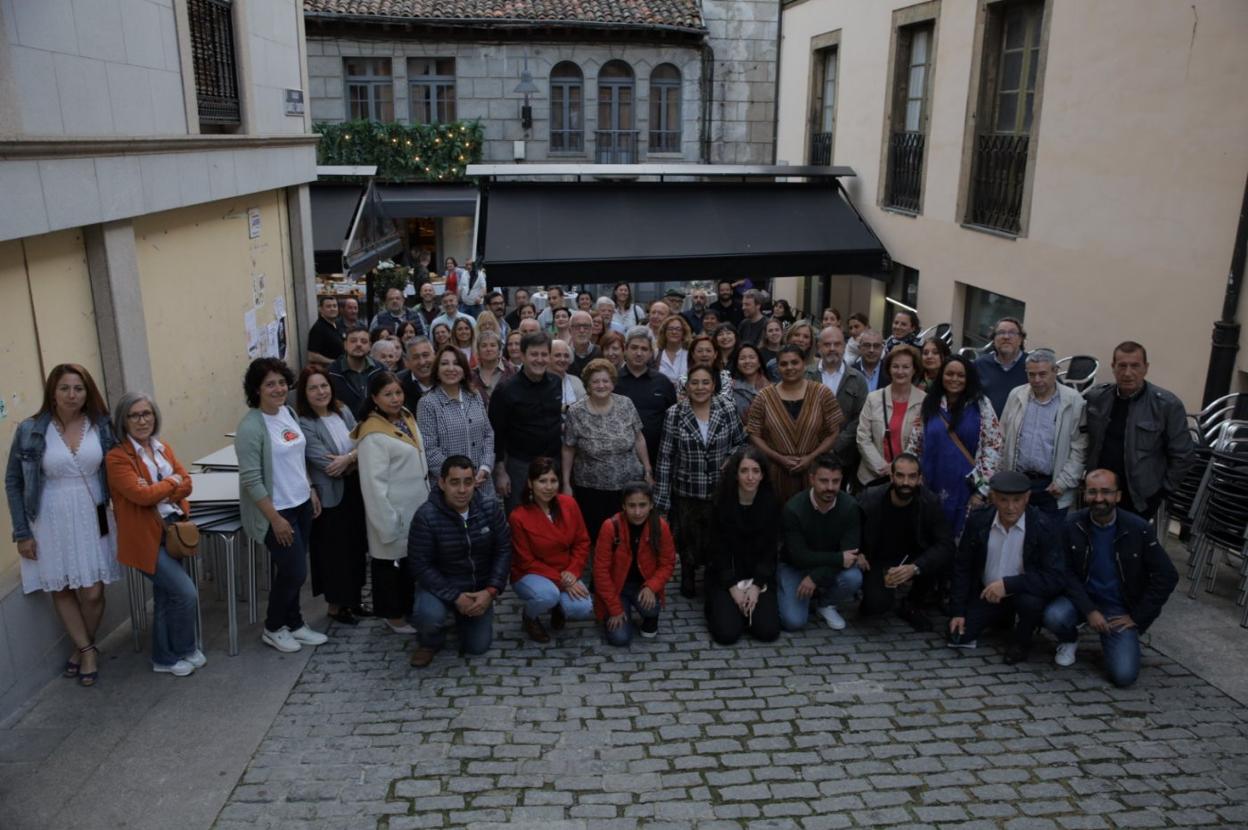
<box><xmin>351</xmin><ymin>371</ymin><xmax>429</xmax><ymax>634</ymax></box>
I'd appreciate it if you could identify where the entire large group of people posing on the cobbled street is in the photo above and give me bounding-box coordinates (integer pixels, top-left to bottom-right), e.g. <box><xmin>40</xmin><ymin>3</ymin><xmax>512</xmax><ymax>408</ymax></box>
<box><xmin>5</xmin><ymin>282</ymin><xmax>1192</xmax><ymax>685</ymax></box>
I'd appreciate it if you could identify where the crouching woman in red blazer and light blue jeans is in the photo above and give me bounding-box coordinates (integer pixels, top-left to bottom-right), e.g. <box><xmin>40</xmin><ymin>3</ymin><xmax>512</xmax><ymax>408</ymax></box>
<box><xmin>510</xmin><ymin>457</ymin><xmax>594</xmax><ymax>643</ymax></box>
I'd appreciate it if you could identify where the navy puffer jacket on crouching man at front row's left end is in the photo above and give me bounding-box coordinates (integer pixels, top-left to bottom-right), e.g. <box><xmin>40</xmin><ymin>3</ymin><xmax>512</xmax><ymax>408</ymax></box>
<box><xmin>407</xmin><ymin>489</ymin><xmax>512</xmax><ymax>604</ymax></box>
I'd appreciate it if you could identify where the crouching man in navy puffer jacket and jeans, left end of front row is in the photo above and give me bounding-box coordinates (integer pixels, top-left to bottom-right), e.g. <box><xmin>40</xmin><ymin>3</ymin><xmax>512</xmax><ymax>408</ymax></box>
<box><xmin>407</xmin><ymin>456</ymin><xmax>512</xmax><ymax>669</ymax></box>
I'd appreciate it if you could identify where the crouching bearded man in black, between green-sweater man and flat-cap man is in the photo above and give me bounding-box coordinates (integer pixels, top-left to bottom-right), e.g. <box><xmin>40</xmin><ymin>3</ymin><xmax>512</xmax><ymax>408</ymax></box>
<box><xmin>859</xmin><ymin>453</ymin><xmax>953</xmax><ymax>632</ymax></box>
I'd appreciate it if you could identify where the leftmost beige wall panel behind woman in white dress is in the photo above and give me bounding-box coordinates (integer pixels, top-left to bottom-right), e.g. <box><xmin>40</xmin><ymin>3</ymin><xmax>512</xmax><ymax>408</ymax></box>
<box><xmin>0</xmin><ymin>231</ymin><xmax>102</xmax><ymax>581</ymax></box>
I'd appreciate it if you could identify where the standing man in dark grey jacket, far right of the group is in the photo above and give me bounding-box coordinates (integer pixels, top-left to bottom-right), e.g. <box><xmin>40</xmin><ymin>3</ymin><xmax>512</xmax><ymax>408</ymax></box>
<box><xmin>1083</xmin><ymin>341</ymin><xmax>1194</xmax><ymax>520</ymax></box>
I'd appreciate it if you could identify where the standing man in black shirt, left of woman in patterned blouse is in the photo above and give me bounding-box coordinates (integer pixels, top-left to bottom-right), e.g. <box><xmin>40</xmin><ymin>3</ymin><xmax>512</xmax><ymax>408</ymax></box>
<box><xmin>489</xmin><ymin>332</ymin><xmax>563</xmax><ymax>513</ymax></box>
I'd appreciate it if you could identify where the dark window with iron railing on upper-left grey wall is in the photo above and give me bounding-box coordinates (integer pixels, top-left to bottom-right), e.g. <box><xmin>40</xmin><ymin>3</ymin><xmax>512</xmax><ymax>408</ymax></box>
<box><xmin>187</xmin><ymin>0</ymin><xmax>241</xmax><ymax>125</ymax></box>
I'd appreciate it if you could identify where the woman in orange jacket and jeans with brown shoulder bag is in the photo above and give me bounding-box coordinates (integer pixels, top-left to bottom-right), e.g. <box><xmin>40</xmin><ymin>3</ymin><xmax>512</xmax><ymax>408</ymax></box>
<box><xmin>105</xmin><ymin>392</ymin><xmax>199</xmax><ymax>678</ymax></box>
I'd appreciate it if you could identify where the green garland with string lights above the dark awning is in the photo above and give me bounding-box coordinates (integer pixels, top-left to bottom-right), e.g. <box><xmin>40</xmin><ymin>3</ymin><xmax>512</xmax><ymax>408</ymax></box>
<box><xmin>312</xmin><ymin>121</ymin><xmax>485</xmax><ymax>182</ymax></box>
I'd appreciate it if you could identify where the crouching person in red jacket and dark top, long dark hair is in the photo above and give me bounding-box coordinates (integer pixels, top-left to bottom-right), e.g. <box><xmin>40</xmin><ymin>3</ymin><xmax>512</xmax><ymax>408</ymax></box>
<box><xmin>594</xmin><ymin>482</ymin><xmax>676</xmax><ymax>645</ymax></box>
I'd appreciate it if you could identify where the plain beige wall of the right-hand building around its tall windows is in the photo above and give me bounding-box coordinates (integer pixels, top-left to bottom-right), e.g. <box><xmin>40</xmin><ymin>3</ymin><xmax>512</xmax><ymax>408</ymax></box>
<box><xmin>779</xmin><ymin>0</ymin><xmax>1248</xmax><ymax>408</ymax></box>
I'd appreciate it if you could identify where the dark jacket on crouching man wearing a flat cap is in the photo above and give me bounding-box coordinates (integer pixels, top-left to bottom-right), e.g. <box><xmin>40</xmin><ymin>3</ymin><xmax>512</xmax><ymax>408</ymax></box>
<box><xmin>948</xmin><ymin>507</ymin><xmax>1066</xmax><ymax>617</ymax></box>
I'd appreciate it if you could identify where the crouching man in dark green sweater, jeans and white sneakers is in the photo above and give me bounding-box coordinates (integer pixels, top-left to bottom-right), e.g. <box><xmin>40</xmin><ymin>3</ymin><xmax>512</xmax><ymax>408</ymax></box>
<box><xmin>776</xmin><ymin>454</ymin><xmax>867</xmax><ymax>632</ymax></box>
